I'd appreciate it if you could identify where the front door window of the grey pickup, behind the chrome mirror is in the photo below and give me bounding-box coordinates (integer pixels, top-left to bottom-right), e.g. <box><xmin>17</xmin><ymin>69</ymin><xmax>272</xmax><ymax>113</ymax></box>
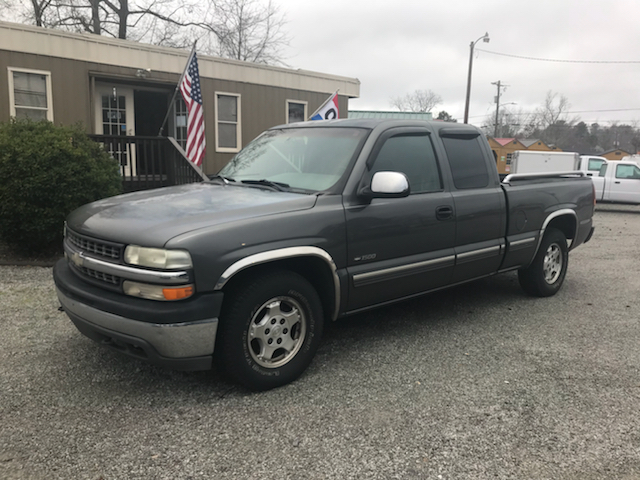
<box><xmin>370</xmin><ymin>135</ymin><xmax>442</xmax><ymax>194</ymax></box>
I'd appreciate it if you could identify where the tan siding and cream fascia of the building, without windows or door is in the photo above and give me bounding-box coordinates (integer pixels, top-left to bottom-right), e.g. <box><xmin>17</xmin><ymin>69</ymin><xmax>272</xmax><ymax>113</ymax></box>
<box><xmin>0</xmin><ymin>22</ymin><xmax>359</xmax><ymax>174</ymax></box>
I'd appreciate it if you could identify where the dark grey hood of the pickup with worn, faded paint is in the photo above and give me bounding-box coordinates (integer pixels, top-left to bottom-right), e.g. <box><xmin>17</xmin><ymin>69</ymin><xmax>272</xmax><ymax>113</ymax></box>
<box><xmin>67</xmin><ymin>183</ymin><xmax>317</xmax><ymax>247</ymax></box>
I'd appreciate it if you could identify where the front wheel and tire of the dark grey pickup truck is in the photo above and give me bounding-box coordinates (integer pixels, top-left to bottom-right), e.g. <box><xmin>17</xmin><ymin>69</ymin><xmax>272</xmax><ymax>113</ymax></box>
<box><xmin>214</xmin><ymin>271</ymin><xmax>323</xmax><ymax>391</ymax></box>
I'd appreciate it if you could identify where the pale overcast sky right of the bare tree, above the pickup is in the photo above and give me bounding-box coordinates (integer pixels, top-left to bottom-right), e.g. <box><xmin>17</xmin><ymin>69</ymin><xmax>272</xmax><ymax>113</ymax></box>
<box><xmin>274</xmin><ymin>0</ymin><xmax>640</xmax><ymax>125</ymax></box>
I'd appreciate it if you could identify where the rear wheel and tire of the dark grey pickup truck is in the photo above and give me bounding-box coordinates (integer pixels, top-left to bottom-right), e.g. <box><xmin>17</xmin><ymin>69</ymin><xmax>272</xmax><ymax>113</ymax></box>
<box><xmin>518</xmin><ymin>228</ymin><xmax>569</xmax><ymax>297</ymax></box>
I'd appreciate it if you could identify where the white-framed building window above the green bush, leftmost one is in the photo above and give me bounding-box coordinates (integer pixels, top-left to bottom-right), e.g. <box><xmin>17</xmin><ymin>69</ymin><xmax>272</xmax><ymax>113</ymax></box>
<box><xmin>9</xmin><ymin>67</ymin><xmax>53</xmax><ymax>122</ymax></box>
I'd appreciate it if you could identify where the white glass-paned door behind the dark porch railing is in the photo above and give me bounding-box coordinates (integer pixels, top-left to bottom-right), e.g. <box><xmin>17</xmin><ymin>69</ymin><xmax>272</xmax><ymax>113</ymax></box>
<box><xmin>94</xmin><ymin>83</ymin><xmax>137</xmax><ymax>176</ymax></box>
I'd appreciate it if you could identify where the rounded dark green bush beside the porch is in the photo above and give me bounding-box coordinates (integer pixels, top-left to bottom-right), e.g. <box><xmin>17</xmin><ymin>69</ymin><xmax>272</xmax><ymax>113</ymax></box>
<box><xmin>0</xmin><ymin>120</ymin><xmax>122</xmax><ymax>255</ymax></box>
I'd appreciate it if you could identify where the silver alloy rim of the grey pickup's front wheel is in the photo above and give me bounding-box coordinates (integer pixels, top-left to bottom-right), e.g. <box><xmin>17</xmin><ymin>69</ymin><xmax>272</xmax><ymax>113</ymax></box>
<box><xmin>247</xmin><ymin>296</ymin><xmax>307</xmax><ymax>368</ymax></box>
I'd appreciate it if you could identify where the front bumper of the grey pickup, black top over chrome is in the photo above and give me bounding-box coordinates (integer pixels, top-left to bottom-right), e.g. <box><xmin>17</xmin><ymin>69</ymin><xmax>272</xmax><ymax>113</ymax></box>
<box><xmin>53</xmin><ymin>259</ymin><xmax>223</xmax><ymax>370</ymax></box>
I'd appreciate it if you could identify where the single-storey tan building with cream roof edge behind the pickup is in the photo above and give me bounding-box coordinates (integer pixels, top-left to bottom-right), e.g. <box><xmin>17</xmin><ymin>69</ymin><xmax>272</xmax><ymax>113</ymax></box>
<box><xmin>0</xmin><ymin>22</ymin><xmax>360</xmax><ymax>183</ymax></box>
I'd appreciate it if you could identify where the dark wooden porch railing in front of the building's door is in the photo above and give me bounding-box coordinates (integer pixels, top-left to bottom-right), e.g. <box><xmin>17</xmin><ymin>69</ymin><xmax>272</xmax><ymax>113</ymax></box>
<box><xmin>90</xmin><ymin>135</ymin><xmax>206</xmax><ymax>192</ymax></box>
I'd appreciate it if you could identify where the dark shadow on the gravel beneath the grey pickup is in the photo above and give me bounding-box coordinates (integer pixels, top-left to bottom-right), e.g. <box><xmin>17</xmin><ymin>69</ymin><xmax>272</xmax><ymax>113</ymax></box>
<box><xmin>57</xmin><ymin>273</ymin><xmax>524</xmax><ymax>398</ymax></box>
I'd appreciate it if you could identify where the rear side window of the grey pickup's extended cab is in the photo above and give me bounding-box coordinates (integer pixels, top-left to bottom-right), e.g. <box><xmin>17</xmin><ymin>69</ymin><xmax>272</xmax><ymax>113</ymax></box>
<box><xmin>442</xmin><ymin>136</ymin><xmax>489</xmax><ymax>189</ymax></box>
